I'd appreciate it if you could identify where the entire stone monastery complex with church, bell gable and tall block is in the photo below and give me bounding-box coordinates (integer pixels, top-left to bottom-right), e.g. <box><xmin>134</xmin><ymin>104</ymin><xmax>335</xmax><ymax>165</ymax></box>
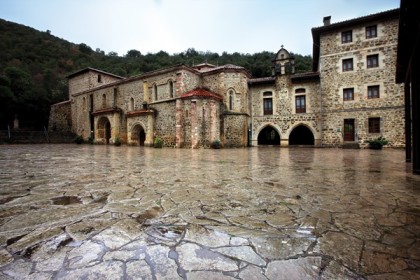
<box><xmin>50</xmin><ymin>9</ymin><xmax>405</xmax><ymax>148</ymax></box>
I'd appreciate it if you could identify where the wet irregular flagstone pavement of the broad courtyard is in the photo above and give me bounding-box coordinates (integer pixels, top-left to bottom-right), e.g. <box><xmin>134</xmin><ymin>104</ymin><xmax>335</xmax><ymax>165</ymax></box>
<box><xmin>0</xmin><ymin>145</ymin><xmax>420</xmax><ymax>280</ymax></box>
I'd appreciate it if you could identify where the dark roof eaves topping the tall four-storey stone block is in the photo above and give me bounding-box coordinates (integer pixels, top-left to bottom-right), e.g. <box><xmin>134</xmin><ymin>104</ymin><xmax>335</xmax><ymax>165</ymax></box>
<box><xmin>312</xmin><ymin>9</ymin><xmax>400</xmax><ymax>72</ymax></box>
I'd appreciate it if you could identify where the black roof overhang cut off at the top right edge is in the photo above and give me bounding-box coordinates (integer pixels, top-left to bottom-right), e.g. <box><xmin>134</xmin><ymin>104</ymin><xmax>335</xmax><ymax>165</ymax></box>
<box><xmin>395</xmin><ymin>0</ymin><xmax>420</xmax><ymax>83</ymax></box>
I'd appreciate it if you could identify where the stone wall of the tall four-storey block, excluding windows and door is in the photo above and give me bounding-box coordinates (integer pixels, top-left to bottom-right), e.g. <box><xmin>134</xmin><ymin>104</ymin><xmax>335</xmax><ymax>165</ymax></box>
<box><xmin>320</xmin><ymin>19</ymin><xmax>404</xmax><ymax>147</ymax></box>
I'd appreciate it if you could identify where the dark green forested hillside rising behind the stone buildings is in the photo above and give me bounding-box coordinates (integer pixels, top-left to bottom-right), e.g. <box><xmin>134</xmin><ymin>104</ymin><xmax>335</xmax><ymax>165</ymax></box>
<box><xmin>0</xmin><ymin>19</ymin><xmax>312</xmax><ymax>130</ymax></box>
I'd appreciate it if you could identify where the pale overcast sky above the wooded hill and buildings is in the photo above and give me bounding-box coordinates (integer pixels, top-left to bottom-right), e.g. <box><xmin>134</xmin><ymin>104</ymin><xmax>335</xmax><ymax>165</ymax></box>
<box><xmin>0</xmin><ymin>0</ymin><xmax>400</xmax><ymax>56</ymax></box>
